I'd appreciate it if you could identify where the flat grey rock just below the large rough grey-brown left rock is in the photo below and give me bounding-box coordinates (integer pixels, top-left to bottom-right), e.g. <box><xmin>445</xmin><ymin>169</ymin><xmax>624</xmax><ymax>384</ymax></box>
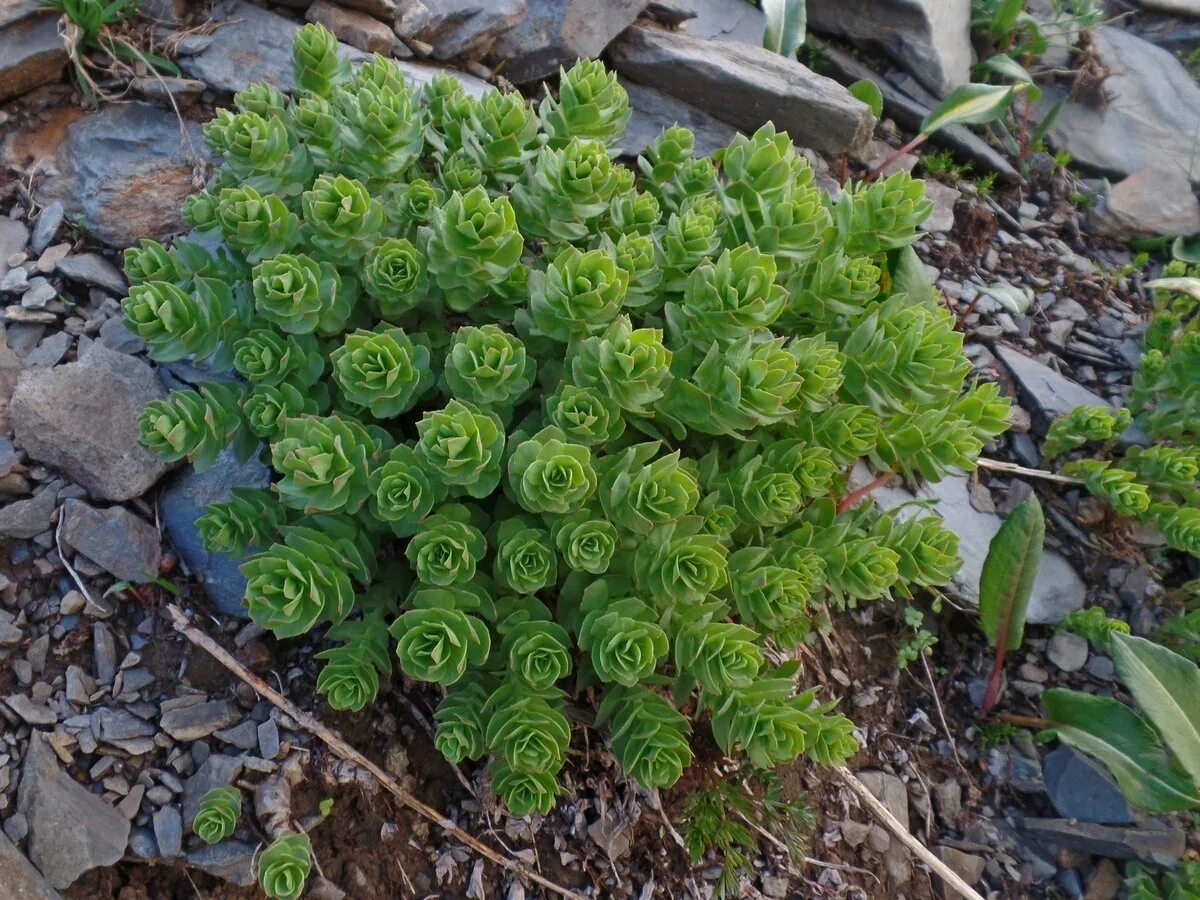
<box><xmin>61</xmin><ymin>499</ymin><xmax>162</xmax><ymax>582</ymax></box>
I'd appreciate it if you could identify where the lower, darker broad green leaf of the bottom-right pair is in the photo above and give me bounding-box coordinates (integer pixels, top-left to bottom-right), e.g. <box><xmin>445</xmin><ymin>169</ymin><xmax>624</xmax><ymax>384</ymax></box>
<box><xmin>1042</xmin><ymin>688</ymin><xmax>1200</xmax><ymax>812</ymax></box>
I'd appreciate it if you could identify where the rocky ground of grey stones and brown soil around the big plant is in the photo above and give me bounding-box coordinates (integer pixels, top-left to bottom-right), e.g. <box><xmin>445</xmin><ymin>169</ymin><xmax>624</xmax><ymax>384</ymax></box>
<box><xmin>0</xmin><ymin>0</ymin><xmax>1200</xmax><ymax>900</ymax></box>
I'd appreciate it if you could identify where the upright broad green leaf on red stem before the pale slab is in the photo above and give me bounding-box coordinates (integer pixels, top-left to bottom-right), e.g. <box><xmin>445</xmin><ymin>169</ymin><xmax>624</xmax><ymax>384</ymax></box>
<box><xmin>979</xmin><ymin>497</ymin><xmax>1046</xmax><ymax>650</ymax></box>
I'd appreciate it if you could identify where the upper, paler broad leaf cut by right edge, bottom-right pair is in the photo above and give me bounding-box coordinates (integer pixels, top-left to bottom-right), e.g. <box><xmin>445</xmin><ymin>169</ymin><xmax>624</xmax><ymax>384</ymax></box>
<box><xmin>1112</xmin><ymin>634</ymin><xmax>1200</xmax><ymax>782</ymax></box>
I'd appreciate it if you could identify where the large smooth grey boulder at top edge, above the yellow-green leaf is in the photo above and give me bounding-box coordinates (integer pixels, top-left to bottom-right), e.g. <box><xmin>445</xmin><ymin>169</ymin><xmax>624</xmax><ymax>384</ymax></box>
<box><xmin>808</xmin><ymin>0</ymin><xmax>973</xmax><ymax>97</ymax></box>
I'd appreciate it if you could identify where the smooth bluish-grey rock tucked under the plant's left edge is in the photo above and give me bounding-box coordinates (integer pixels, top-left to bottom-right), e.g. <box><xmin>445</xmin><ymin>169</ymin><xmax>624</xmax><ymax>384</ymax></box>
<box><xmin>160</xmin><ymin>449</ymin><xmax>271</xmax><ymax>618</ymax></box>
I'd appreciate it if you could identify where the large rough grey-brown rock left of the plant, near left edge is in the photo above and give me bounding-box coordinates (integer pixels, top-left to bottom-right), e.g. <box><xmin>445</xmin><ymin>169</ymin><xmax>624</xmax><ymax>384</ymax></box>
<box><xmin>10</xmin><ymin>343</ymin><xmax>172</xmax><ymax>500</ymax></box>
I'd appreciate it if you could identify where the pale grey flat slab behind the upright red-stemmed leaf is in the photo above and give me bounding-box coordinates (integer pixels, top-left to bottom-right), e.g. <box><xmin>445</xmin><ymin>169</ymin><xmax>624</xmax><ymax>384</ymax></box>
<box><xmin>853</xmin><ymin>468</ymin><xmax>1087</xmax><ymax>625</ymax></box>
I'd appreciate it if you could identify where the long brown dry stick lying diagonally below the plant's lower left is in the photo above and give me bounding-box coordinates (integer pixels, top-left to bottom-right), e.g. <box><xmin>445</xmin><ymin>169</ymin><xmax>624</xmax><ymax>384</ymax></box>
<box><xmin>167</xmin><ymin>604</ymin><xmax>586</xmax><ymax>900</ymax></box>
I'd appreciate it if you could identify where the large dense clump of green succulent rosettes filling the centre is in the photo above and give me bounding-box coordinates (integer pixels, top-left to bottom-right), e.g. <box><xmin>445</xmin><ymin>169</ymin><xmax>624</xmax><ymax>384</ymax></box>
<box><xmin>125</xmin><ymin>25</ymin><xmax>1008</xmax><ymax>815</ymax></box>
